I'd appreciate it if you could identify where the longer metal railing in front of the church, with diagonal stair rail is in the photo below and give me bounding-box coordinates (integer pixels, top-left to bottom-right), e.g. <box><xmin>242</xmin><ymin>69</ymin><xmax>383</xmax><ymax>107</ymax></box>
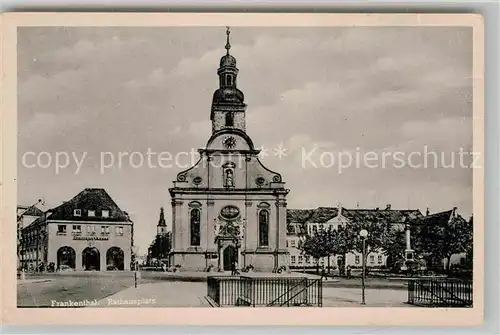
<box><xmin>207</xmin><ymin>276</ymin><xmax>323</xmax><ymax>307</ymax></box>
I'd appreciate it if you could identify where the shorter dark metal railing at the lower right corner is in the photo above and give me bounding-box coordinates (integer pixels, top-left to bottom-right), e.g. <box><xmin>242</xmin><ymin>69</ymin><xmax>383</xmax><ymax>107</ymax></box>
<box><xmin>408</xmin><ymin>278</ymin><xmax>473</xmax><ymax>307</ymax></box>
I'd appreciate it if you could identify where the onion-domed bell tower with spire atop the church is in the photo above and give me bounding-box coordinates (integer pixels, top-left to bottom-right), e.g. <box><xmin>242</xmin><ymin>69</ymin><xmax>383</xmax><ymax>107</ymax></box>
<box><xmin>210</xmin><ymin>27</ymin><xmax>246</xmax><ymax>133</ymax></box>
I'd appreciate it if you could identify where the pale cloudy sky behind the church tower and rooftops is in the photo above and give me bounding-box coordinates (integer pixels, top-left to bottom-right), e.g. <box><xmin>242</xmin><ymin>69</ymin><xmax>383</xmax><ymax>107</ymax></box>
<box><xmin>18</xmin><ymin>27</ymin><xmax>472</xmax><ymax>253</ymax></box>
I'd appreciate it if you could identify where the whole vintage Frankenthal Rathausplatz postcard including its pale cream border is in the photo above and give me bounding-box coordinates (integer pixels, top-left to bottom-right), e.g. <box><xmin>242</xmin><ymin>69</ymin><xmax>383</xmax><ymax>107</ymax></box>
<box><xmin>0</xmin><ymin>13</ymin><xmax>484</xmax><ymax>325</ymax></box>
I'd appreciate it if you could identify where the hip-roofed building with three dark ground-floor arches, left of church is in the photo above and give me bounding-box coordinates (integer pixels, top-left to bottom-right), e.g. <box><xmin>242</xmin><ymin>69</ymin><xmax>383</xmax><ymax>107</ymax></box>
<box><xmin>20</xmin><ymin>188</ymin><xmax>133</xmax><ymax>271</ymax></box>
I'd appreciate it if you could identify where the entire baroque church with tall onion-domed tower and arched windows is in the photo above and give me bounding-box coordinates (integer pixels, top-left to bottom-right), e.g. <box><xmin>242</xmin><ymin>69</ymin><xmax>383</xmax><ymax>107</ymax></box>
<box><xmin>169</xmin><ymin>30</ymin><xmax>289</xmax><ymax>272</ymax></box>
